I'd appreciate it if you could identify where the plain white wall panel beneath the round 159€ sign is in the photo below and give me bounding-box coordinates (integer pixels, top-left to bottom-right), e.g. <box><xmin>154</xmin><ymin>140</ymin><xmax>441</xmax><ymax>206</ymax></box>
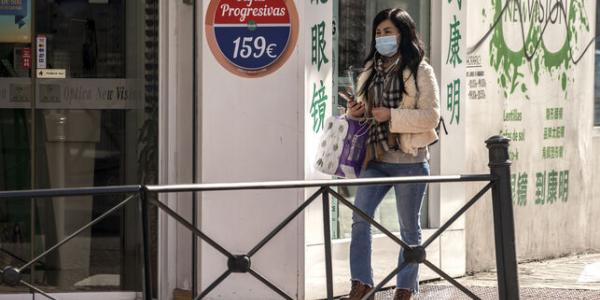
<box><xmin>198</xmin><ymin>1</ymin><xmax>306</xmax><ymax>299</ymax></box>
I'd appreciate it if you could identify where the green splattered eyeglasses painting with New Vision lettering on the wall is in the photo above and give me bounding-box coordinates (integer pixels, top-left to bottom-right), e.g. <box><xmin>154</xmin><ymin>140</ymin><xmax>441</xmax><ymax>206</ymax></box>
<box><xmin>482</xmin><ymin>0</ymin><xmax>590</xmax><ymax>99</ymax></box>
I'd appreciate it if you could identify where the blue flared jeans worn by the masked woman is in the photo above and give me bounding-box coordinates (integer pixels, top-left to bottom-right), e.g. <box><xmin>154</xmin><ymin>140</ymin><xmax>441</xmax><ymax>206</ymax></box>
<box><xmin>350</xmin><ymin>161</ymin><xmax>429</xmax><ymax>292</ymax></box>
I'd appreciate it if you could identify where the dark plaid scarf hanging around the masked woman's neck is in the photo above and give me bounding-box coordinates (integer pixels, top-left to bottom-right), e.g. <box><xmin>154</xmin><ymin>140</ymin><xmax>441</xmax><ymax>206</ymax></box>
<box><xmin>367</xmin><ymin>59</ymin><xmax>403</xmax><ymax>151</ymax></box>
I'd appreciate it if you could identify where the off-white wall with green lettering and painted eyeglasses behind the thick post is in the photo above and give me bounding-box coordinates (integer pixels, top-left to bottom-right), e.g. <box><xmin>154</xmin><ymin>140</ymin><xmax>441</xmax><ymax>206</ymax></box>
<box><xmin>463</xmin><ymin>0</ymin><xmax>600</xmax><ymax>271</ymax></box>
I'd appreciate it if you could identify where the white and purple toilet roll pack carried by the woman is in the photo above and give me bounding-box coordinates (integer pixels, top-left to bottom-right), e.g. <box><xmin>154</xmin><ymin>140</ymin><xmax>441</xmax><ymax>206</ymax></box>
<box><xmin>314</xmin><ymin>115</ymin><xmax>369</xmax><ymax>178</ymax></box>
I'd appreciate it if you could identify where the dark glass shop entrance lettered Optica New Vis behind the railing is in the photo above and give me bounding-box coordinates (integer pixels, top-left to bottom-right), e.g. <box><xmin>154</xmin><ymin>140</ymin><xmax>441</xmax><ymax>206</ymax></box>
<box><xmin>0</xmin><ymin>0</ymin><xmax>158</xmax><ymax>291</ymax></box>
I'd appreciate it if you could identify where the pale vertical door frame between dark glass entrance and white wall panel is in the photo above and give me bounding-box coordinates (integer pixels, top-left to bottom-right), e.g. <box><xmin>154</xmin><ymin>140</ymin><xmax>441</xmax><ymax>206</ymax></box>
<box><xmin>155</xmin><ymin>0</ymin><xmax>195</xmax><ymax>299</ymax></box>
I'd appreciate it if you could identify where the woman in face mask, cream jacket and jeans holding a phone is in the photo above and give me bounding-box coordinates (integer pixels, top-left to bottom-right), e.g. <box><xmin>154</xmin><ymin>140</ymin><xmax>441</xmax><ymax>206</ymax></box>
<box><xmin>347</xmin><ymin>8</ymin><xmax>439</xmax><ymax>299</ymax></box>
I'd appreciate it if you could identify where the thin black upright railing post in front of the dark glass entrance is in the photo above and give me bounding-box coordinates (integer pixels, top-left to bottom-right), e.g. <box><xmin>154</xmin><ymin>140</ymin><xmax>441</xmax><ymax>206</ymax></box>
<box><xmin>139</xmin><ymin>186</ymin><xmax>152</xmax><ymax>300</ymax></box>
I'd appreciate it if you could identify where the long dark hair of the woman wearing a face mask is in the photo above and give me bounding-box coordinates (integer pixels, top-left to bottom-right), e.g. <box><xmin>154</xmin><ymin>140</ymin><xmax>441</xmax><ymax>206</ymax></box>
<box><xmin>359</xmin><ymin>8</ymin><xmax>425</xmax><ymax>95</ymax></box>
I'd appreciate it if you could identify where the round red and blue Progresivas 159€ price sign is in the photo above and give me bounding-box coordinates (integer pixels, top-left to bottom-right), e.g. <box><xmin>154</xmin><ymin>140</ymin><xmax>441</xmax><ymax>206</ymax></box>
<box><xmin>205</xmin><ymin>0</ymin><xmax>298</xmax><ymax>77</ymax></box>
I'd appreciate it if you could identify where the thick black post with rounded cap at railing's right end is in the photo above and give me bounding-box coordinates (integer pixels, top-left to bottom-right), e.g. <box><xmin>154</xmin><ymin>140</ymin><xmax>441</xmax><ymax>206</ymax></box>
<box><xmin>485</xmin><ymin>136</ymin><xmax>519</xmax><ymax>300</ymax></box>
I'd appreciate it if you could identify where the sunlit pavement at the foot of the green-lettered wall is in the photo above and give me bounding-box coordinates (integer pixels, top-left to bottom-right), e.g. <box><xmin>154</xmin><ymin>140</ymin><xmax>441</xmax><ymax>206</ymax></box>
<box><xmin>376</xmin><ymin>253</ymin><xmax>600</xmax><ymax>300</ymax></box>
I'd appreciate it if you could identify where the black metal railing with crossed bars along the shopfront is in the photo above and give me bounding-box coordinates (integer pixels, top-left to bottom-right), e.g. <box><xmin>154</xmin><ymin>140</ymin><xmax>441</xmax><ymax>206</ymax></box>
<box><xmin>0</xmin><ymin>136</ymin><xmax>519</xmax><ymax>300</ymax></box>
